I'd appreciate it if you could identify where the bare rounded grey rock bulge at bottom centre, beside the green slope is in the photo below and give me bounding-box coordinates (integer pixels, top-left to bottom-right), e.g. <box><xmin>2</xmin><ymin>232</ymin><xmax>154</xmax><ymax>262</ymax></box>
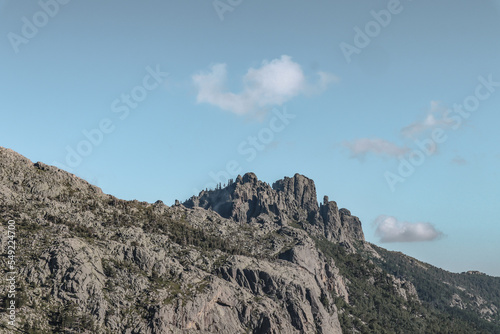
<box><xmin>218</xmin><ymin>257</ymin><xmax>342</xmax><ymax>333</ymax></box>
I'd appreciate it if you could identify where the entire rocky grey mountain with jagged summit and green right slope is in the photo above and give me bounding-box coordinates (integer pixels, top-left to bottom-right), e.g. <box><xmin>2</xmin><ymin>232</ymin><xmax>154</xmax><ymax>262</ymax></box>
<box><xmin>0</xmin><ymin>148</ymin><xmax>500</xmax><ymax>334</ymax></box>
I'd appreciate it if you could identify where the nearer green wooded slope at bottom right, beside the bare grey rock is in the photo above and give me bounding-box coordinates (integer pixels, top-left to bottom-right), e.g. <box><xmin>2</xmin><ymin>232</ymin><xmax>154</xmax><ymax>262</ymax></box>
<box><xmin>315</xmin><ymin>238</ymin><xmax>498</xmax><ymax>334</ymax></box>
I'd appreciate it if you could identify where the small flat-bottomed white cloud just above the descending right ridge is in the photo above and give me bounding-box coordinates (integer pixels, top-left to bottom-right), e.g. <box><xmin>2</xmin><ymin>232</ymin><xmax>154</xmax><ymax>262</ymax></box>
<box><xmin>374</xmin><ymin>215</ymin><xmax>443</xmax><ymax>242</ymax></box>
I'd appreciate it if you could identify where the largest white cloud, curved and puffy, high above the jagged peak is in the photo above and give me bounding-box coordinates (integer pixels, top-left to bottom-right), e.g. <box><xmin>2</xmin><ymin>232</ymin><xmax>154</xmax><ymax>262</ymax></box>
<box><xmin>193</xmin><ymin>55</ymin><xmax>338</xmax><ymax>115</ymax></box>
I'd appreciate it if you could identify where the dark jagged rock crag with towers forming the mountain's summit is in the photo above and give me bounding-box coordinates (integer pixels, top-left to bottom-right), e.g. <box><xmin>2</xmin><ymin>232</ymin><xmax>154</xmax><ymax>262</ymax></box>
<box><xmin>184</xmin><ymin>173</ymin><xmax>364</xmax><ymax>247</ymax></box>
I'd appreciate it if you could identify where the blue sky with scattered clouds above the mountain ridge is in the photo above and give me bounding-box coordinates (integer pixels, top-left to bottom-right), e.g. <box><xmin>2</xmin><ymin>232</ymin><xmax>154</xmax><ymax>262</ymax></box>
<box><xmin>0</xmin><ymin>0</ymin><xmax>500</xmax><ymax>276</ymax></box>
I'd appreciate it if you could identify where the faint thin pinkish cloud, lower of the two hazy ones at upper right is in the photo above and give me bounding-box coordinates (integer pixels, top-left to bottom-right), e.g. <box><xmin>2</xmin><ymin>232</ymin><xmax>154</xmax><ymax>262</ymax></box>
<box><xmin>344</xmin><ymin>138</ymin><xmax>409</xmax><ymax>158</ymax></box>
